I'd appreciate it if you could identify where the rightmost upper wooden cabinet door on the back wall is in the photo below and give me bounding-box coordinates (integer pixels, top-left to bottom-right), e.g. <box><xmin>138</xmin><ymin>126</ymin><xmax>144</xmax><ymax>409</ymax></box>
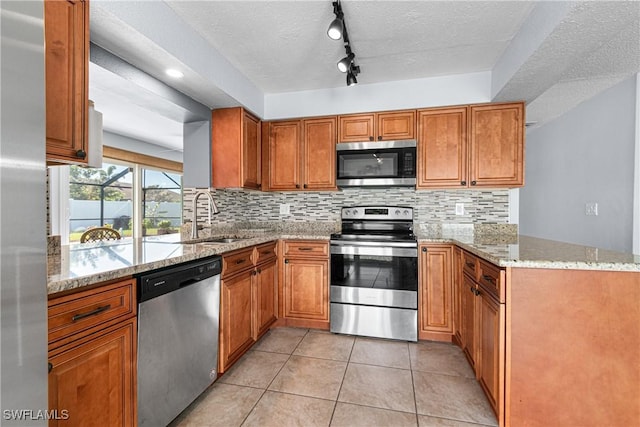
<box><xmin>470</xmin><ymin>102</ymin><xmax>524</xmax><ymax>187</ymax></box>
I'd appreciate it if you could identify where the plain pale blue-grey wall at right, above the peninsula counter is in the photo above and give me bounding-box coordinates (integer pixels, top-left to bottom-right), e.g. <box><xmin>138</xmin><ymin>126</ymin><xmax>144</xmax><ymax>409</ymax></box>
<box><xmin>520</xmin><ymin>76</ymin><xmax>636</xmax><ymax>252</ymax></box>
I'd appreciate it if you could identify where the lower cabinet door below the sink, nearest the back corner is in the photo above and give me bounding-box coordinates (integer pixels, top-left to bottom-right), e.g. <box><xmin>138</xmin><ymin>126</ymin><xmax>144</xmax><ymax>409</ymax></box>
<box><xmin>254</xmin><ymin>259</ymin><xmax>278</xmax><ymax>340</ymax></box>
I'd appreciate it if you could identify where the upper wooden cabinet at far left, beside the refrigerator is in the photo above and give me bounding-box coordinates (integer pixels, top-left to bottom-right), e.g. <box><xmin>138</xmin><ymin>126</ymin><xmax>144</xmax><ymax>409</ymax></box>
<box><xmin>44</xmin><ymin>0</ymin><xmax>89</xmax><ymax>163</ymax></box>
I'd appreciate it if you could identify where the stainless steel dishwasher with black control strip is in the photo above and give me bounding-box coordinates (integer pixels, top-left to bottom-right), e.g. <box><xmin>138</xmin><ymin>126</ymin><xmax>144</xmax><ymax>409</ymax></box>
<box><xmin>138</xmin><ymin>257</ymin><xmax>221</xmax><ymax>427</ymax></box>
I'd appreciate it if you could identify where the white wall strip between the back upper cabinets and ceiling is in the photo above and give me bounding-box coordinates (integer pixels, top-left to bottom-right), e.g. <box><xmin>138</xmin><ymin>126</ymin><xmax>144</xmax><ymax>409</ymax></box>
<box><xmin>263</xmin><ymin>71</ymin><xmax>491</xmax><ymax>120</ymax></box>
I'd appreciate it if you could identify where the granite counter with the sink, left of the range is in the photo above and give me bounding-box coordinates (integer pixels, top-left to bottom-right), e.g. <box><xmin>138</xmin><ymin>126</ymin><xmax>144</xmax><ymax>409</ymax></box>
<box><xmin>47</xmin><ymin>229</ymin><xmax>331</xmax><ymax>294</ymax></box>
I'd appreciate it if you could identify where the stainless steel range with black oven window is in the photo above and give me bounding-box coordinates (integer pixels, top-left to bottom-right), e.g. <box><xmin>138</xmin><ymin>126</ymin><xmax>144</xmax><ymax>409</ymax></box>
<box><xmin>330</xmin><ymin>206</ymin><xmax>418</xmax><ymax>341</ymax></box>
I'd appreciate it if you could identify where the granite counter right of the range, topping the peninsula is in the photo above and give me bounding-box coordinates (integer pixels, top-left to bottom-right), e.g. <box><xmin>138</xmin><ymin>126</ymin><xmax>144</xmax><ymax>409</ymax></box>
<box><xmin>418</xmin><ymin>232</ymin><xmax>640</xmax><ymax>271</ymax></box>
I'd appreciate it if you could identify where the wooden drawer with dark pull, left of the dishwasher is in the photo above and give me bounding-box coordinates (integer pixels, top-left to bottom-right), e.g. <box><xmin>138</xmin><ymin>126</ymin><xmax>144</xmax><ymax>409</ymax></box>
<box><xmin>48</xmin><ymin>279</ymin><xmax>136</xmax><ymax>347</ymax></box>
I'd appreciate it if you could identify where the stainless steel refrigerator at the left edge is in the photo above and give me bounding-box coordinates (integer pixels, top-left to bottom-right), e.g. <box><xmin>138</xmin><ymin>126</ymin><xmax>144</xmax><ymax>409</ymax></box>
<box><xmin>0</xmin><ymin>0</ymin><xmax>47</xmax><ymax>426</ymax></box>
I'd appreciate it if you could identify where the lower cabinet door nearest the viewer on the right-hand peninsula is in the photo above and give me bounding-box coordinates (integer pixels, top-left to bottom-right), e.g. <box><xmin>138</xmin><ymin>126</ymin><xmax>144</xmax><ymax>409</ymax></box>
<box><xmin>477</xmin><ymin>288</ymin><xmax>504</xmax><ymax>420</ymax></box>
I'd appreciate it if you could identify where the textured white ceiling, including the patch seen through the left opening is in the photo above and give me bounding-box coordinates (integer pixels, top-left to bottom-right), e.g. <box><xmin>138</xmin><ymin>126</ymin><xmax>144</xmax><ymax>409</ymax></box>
<box><xmin>90</xmin><ymin>0</ymin><xmax>640</xmax><ymax>149</ymax></box>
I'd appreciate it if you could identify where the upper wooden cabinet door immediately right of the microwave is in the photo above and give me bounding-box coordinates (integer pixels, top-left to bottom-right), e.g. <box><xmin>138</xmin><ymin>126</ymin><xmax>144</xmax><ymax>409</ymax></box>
<box><xmin>416</xmin><ymin>107</ymin><xmax>468</xmax><ymax>188</ymax></box>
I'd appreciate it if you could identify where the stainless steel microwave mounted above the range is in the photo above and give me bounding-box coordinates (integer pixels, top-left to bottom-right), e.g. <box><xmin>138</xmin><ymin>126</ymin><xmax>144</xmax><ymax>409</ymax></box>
<box><xmin>336</xmin><ymin>140</ymin><xmax>416</xmax><ymax>187</ymax></box>
